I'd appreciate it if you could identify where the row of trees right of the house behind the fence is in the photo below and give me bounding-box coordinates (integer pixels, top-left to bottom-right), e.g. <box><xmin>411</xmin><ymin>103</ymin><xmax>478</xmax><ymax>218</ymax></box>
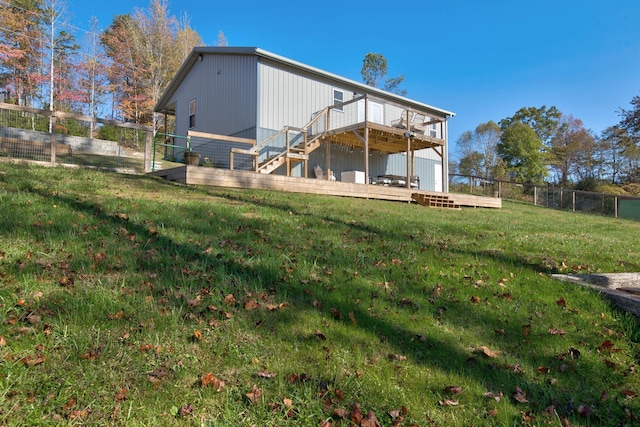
<box><xmin>452</xmin><ymin>101</ymin><xmax>640</xmax><ymax>191</ymax></box>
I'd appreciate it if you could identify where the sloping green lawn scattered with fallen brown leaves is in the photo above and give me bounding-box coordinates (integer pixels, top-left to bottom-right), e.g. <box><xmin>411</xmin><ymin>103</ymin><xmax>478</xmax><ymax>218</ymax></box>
<box><xmin>0</xmin><ymin>164</ymin><xmax>640</xmax><ymax>426</ymax></box>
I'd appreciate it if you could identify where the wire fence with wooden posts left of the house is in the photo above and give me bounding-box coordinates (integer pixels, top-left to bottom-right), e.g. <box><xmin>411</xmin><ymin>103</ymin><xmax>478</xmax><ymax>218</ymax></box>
<box><xmin>0</xmin><ymin>103</ymin><xmax>153</xmax><ymax>173</ymax></box>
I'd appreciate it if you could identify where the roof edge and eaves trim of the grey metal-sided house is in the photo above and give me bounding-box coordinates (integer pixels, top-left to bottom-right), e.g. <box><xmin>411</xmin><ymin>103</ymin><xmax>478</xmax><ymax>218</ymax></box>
<box><xmin>154</xmin><ymin>46</ymin><xmax>455</xmax><ymax>117</ymax></box>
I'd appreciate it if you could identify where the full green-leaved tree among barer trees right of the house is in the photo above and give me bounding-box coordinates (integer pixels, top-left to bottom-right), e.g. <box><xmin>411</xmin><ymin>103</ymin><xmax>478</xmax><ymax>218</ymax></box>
<box><xmin>497</xmin><ymin>121</ymin><xmax>547</xmax><ymax>184</ymax></box>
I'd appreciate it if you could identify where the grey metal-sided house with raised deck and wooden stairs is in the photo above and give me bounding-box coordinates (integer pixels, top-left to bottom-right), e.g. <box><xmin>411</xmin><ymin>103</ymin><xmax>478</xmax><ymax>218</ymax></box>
<box><xmin>155</xmin><ymin>47</ymin><xmax>454</xmax><ymax>192</ymax></box>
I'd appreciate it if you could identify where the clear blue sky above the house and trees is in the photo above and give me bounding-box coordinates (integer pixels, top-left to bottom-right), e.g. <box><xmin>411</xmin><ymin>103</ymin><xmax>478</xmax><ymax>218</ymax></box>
<box><xmin>67</xmin><ymin>0</ymin><xmax>640</xmax><ymax>160</ymax></box>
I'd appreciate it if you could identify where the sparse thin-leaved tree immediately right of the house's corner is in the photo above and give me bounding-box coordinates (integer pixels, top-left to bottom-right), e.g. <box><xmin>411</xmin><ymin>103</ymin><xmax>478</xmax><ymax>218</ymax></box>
<box><xmin>457</xmin><ymin>120</ymin><xmax>502</xmax><ymax>178</ymax></box>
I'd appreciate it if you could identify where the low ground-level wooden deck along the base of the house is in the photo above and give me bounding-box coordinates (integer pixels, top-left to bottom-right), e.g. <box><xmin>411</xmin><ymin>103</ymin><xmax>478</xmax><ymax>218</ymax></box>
<box><xmin>151</xmin><ymin>166</ymin><xmax>502</xmax><ymax>209</ymax></box>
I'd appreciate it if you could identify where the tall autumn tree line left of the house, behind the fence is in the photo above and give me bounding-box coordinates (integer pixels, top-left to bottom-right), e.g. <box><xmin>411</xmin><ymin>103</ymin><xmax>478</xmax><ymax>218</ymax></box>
<box><xmin>0</xmin><ymin>0</ymin><xmax>220</xmax><ymax>130</ymax></box>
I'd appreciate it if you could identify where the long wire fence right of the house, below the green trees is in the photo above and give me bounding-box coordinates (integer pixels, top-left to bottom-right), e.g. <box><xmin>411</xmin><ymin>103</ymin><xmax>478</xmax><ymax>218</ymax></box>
<box><xmin>449</xmin><ymin>174</ymin><xmax>640</xmax><ymax>220</ymax></box>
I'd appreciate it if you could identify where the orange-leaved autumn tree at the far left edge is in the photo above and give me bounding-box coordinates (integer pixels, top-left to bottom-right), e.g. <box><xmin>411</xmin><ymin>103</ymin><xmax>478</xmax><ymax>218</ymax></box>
<box><xmin>0</xmin><ymin>0</ymin><xmax>45</xmax><ymax>105</ymax></box>
